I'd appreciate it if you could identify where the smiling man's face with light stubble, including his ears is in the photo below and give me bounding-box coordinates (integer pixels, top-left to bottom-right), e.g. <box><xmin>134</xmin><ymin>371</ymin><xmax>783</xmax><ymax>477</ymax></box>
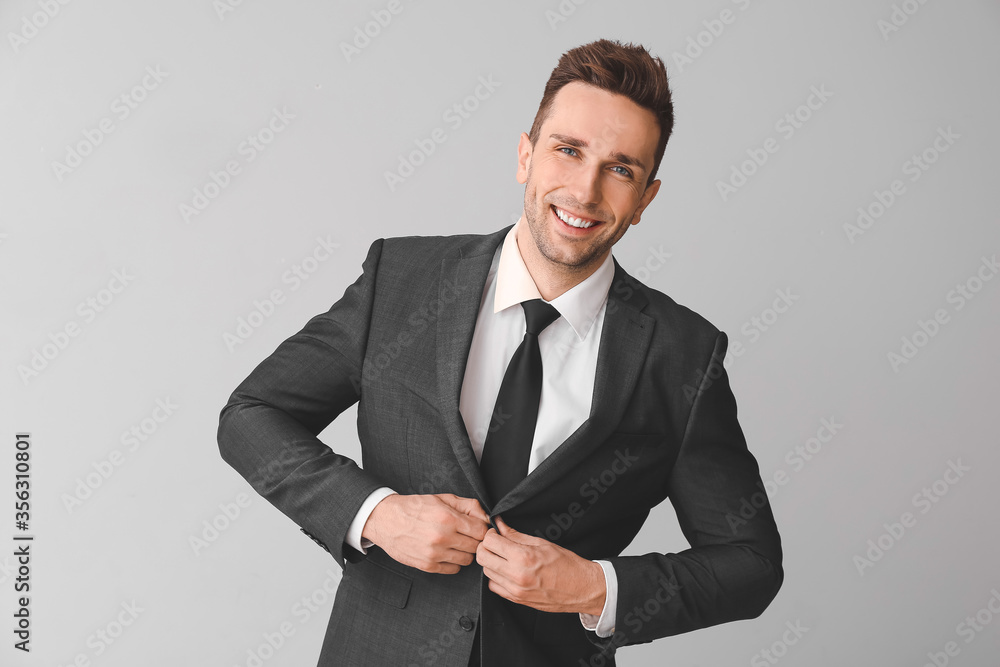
<box><xmin>517</xmin><ymin>82</ymin><xmax>660</xmax><ymax>277</ymax></box>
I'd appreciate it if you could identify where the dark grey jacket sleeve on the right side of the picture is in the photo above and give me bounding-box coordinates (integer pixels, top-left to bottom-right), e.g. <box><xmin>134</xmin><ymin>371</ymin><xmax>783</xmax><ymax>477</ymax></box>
<box><xmin>606</xmin><ymin>332</ymin><xmax>784</xmax><ymax>646</ymax></box>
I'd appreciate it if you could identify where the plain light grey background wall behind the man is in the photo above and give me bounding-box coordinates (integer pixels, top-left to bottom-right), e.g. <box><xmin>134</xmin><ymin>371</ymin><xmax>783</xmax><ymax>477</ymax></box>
<box><xmin>0</xmin><ymin>0</ymin><xmax>1000</xmax><ymax>667</ymax></box>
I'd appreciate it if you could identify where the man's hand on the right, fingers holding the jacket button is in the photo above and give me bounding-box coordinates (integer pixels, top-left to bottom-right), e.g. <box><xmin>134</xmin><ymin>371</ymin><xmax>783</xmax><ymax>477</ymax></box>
<box><xmin>476</xmin><ymin>517</ymin><xmax>606</xmax><ymax>616</ymax></box>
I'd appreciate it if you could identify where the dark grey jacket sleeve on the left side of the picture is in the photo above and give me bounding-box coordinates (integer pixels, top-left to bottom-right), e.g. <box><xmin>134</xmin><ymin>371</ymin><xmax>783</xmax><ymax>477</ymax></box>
<box><xmin>218</xmin><ymin>239</ymin><xmax>383</xmax><ymax>566</ymax></box>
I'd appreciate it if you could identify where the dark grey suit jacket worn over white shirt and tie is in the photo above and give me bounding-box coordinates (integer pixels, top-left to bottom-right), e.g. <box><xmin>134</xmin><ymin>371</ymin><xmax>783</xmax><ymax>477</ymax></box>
<box><xmin>219</xmin><ymin>227</ymin><xmax>783</xmax><ymax>667</ymax></box>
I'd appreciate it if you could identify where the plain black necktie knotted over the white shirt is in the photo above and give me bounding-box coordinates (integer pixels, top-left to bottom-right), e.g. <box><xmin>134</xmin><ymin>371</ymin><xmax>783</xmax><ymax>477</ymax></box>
<box><xmin>480</xmin><ymin>299</ymin><xmax>559</xmax><ymax>504</ymax></box>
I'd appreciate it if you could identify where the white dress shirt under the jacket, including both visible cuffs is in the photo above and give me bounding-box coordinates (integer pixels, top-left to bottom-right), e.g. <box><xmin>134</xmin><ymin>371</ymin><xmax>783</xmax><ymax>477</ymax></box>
<box><xmin>346</xmin><ymin>217</ymin><xmax>618</xmax><ymax>637</ymax></box>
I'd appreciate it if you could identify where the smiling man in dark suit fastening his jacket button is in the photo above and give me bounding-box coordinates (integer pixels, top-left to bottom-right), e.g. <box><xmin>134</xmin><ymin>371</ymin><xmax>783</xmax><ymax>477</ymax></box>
<box><xmin>219</xmin><ymin>40</ymin><xmax>783</xmax><ymax>667</ymax></box>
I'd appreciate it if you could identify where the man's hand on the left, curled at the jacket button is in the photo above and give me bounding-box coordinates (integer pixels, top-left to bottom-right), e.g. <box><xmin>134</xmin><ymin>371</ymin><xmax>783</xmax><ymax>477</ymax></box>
<box><xmin>361</xmin><ymin>493</ymin><xmax>490</xmax><ymax>574</ymax></box>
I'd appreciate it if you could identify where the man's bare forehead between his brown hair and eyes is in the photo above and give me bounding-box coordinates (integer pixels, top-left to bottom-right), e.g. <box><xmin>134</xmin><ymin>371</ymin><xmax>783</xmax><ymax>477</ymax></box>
<box><xmin>540</xmin><ymin>81</ymin><xmax>660</xmax><ymax>168</ymax></box>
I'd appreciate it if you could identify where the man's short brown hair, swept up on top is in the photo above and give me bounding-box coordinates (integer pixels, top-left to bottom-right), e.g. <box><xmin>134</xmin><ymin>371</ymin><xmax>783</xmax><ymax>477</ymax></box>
<box><xmin>528</xmin><ymin>39</ymin><xmax>674</xmax><ymax>185</ymax></box>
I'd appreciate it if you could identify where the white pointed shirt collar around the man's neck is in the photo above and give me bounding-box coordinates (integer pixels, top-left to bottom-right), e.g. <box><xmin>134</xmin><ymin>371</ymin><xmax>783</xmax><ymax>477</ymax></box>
<box><xmin>493</xmin><ymin>216</ymin><xmax>615</xmax><ymax>341</ymax></box>
